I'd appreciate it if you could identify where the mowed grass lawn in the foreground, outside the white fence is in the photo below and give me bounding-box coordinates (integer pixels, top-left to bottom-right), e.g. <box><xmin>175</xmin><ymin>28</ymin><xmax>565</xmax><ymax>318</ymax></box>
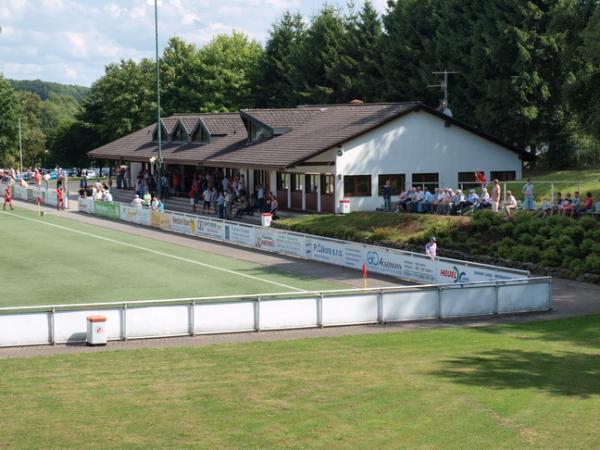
<box><xmin>0</xmin><ymin>316</ymin><xmax>600</xmax><ymax>449</ymax></box>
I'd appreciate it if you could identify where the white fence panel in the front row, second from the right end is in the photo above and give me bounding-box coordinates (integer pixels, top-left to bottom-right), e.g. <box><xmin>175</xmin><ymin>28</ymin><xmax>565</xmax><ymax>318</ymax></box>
<box><xmin>441</xmin><ymin>286</ymin><xmax>496</xmax><ymax>318</ymax></box>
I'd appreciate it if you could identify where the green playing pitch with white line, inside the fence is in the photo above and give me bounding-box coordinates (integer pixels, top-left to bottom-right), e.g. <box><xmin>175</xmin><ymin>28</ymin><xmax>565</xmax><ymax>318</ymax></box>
<box><xmin>0</xmin><ymin>209</ymin><xmax>349</xmax><ymax>306</ymax></box>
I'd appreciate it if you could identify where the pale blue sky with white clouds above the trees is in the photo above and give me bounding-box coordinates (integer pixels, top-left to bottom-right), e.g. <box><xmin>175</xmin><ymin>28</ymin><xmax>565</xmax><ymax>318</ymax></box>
<box><xmin>0</xmin><ymin>0</ymin><xmax>386</xmax><ymax>86</ymax></box>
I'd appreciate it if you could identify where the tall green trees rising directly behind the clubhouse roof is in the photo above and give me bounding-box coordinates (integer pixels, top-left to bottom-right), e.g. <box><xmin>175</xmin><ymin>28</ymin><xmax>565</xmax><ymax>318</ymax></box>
<box><xmin>0</xmin><ymin>0</ymin><xmax>600</xmax><ymax>167</ymax></box>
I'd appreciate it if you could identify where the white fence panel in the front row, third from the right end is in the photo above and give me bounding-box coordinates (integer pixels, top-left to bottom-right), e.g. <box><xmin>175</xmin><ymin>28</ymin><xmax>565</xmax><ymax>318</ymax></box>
<box><xmin>382</xmin><ymin>289</ymin><xmax>439</xmax><ymax>322</ymax></box>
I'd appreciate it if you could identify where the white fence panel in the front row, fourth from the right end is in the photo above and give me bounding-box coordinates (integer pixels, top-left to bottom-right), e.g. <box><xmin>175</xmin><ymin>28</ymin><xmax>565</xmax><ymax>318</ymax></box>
<box><xmin>322</xmin><ymin>294</ymin><xmax>378</xmax><ymax>326</ymax></box>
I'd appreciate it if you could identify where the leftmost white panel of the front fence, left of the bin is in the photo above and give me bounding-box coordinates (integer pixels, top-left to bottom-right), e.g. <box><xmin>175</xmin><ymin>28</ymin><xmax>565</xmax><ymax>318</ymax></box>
<box><xmin>0</xmin><ymin>312</ymin><xmax>51</xmax><ymax>347</ymax></box>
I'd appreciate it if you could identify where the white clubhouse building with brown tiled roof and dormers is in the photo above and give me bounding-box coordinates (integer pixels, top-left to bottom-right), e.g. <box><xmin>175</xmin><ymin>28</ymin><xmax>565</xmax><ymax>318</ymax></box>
<box><xmin>89</xmin><ymin>102</ymin><xmax>530</xmax><ymax>213</ymax></box>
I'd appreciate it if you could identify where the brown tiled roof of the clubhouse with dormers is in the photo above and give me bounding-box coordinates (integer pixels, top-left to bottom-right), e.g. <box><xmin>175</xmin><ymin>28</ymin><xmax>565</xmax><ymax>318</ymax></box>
<box><xmin>89</xmin><ymin>102</ymin><xmax>527</xmax><ymax>168</ymax></box>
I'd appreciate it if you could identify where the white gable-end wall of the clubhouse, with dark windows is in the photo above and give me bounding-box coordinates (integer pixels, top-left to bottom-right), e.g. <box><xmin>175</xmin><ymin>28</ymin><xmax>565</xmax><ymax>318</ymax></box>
<box><xmin>336</xmin><ymin>111</ymin><xmax>522</xmax><ymax>211</ymax></box>
